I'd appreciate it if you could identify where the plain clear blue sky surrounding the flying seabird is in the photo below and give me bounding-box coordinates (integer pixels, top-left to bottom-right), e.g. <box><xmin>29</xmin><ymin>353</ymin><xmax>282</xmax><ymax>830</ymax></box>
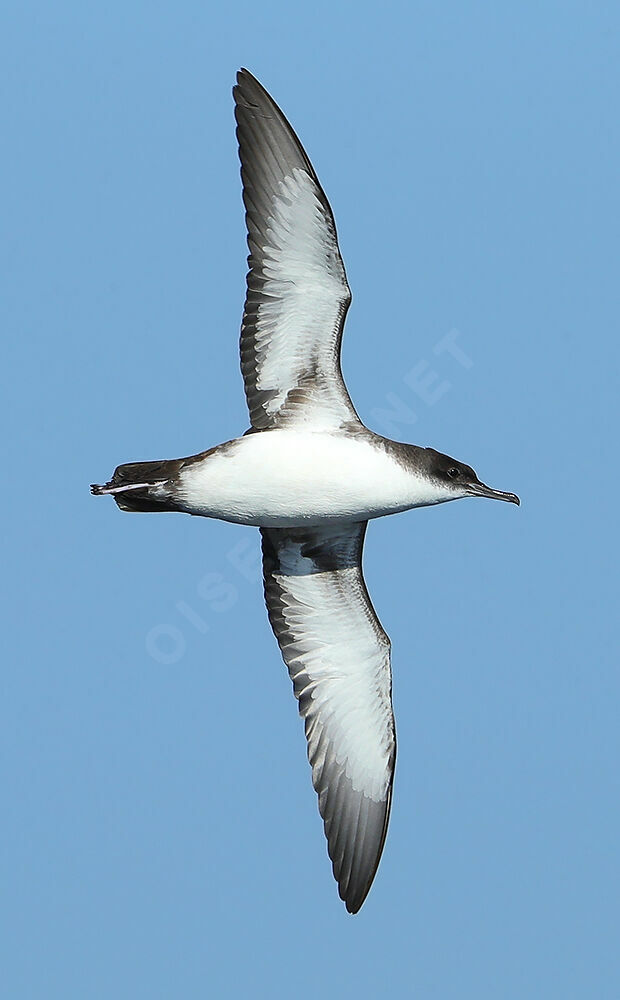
<box><xmin>0</xmin><ymin>0</ymin><xmax>620</xmax><ymax>1000</ymax></box>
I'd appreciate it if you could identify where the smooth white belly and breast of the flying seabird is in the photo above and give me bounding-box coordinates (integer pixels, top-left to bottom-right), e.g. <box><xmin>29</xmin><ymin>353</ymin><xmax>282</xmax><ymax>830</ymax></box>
<box><xmin>178</xmin><ymin>430</ymin><xmax>446</xmax><ymax>527</ymax></box>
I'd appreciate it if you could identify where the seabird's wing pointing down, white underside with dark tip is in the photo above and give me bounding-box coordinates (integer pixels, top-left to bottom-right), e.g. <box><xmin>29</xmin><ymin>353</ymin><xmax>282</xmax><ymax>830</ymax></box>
<box><xmin>261</xmin><ymin>523</ymin><xmax>396</xmax><ymax>913</ymax></box>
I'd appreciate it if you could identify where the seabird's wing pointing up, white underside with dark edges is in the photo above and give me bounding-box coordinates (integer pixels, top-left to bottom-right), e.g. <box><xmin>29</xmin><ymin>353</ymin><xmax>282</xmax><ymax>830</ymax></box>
<box><xmin>233</xmin><ymin>69</ymin><xmax>359</xmax><ymax>430</ymax></box>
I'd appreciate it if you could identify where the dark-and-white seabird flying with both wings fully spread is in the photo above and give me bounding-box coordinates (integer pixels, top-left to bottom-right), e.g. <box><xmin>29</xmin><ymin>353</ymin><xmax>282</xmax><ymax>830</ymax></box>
<box><xmin>91</xmin><ymin>69</ymin><xmax>519</xmax><ymax>913</ymax></box>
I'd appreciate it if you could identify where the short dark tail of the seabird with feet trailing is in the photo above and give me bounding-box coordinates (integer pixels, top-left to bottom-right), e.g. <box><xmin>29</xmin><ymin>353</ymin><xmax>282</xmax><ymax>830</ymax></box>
<box><xmin>90</xmin><ymin>459</ymin><xmax>180</xmax><ymax>513</ymax></box>
